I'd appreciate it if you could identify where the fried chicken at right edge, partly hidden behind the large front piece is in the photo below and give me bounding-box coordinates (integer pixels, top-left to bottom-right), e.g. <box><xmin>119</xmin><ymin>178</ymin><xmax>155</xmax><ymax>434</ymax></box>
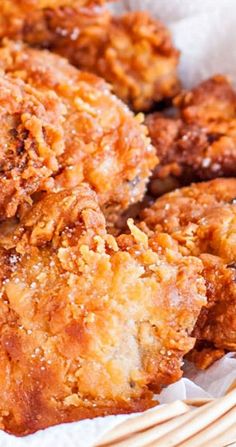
<box><xmin>141</xmin><ymin>179</ymin><xmax>236</xmax><ymax>368</ymax></box>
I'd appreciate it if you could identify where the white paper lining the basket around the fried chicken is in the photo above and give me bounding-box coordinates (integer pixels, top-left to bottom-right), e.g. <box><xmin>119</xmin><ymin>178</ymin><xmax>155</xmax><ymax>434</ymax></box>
<box><xmin>0</xmin><ymin>0</ymin><xmax>236</xmax><ymax>447</ymax></box>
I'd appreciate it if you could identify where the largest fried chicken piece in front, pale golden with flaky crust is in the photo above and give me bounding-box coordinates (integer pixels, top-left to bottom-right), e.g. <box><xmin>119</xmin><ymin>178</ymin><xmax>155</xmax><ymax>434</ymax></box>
<box><xmin>0</xmin><ymin>184</ymin><xmax>206</xmax><ymax>435</ymax></box>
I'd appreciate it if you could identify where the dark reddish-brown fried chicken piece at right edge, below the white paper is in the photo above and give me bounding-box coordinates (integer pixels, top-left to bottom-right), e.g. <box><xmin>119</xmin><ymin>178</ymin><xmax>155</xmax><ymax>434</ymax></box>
<box><xmin>146</xmin><ymin>76</ymin><xmax>236</xmax><ymax>195</ymax></box>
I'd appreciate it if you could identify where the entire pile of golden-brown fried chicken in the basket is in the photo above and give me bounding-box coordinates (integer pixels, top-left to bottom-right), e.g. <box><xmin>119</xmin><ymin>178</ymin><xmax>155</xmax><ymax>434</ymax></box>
<box><xmin>0</xmin><ymin>0</ymin><xmax>236</xmax><ymax>436</ymax></box>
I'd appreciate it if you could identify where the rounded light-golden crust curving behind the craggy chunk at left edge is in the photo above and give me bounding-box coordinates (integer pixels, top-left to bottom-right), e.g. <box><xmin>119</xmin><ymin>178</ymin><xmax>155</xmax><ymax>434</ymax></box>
<box><xmin>0</xmin><ymin>42</ymin><xmax>157</xmax><ymax>220</ymax></box>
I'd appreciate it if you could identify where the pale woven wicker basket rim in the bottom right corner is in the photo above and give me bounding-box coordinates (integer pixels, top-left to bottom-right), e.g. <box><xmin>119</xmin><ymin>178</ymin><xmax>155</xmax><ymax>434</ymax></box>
<box><xmin>96</xmin><ymin>384</ymin><xmax>236</xmax><ymax>447</ymax></box>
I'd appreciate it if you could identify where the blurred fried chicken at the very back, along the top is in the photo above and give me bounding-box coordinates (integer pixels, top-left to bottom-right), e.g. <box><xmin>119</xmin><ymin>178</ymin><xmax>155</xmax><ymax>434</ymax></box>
<box><xmin>0</xmin><ymin>2</ymin><xmax>179</xmax><ymax>111</ymax></box>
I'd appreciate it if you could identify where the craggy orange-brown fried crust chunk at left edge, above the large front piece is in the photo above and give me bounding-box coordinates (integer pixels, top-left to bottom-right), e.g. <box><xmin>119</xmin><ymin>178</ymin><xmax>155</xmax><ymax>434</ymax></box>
<box><xmin>0</xmin><ymin>73</ymin><xmax>64</xmax><ymax>219</ymax></box>
